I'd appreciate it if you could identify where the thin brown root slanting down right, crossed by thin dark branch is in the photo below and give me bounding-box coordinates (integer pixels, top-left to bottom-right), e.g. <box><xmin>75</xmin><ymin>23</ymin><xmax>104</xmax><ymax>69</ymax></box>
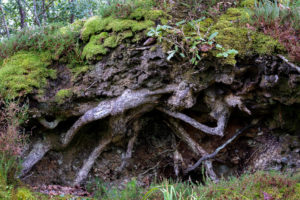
<box><xmin>167</xmin><ymin>118</ymin><xmax>218</xmax><ymax>182</ymax></box>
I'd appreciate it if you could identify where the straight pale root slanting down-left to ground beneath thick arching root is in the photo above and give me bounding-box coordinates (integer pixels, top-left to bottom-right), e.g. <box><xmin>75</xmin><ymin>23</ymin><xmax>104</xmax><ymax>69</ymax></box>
<box><xmin>73</xmin><ymin>136</ymin><xmax>112</xmax><ymax>185</ymax></box>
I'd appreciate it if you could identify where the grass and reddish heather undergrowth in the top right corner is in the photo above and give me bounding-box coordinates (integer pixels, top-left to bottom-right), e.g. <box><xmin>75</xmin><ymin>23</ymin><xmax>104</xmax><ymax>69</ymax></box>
<box><xmin>248</xmin><ymin>0</ymin><xmax>300</xmax><ymax>62</ymax></box>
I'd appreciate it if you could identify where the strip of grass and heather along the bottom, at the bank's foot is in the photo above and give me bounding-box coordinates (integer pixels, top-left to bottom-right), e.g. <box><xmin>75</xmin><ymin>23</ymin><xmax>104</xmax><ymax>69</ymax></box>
<box><xmin>85</xmin><ymin>171</ymin><xmax>300</xmax><ymax>200</ymax></box>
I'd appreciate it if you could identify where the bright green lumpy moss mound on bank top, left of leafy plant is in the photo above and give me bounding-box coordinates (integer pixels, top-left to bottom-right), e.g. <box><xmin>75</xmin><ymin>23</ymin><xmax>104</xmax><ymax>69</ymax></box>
<box><xmin>81</xmin><ymin>8</ymin><xmax>169</xmax><ymax>60</ymax></box>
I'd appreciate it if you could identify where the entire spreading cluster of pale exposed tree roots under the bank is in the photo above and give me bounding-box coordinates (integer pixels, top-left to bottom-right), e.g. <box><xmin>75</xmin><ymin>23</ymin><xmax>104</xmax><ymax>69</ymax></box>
<box><xmin>22</xmin><ymin>83</ymin><xmax>250</xmax><ymax>185</ymax></box>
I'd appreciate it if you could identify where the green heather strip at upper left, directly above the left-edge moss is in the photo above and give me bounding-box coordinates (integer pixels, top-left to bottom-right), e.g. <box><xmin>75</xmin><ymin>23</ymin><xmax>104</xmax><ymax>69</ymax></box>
<box><xmin>0</xmin><ymin>24</ymin><xmax>82</xmax><ymax>64</ymax></box>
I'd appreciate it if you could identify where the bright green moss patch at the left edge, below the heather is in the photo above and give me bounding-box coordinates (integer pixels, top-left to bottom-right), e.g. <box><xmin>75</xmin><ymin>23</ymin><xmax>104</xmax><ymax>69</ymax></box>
<box><xmin>0</xmin><ymin>52</ymin><xmax>56</xmax><ymax>98</ymax></box>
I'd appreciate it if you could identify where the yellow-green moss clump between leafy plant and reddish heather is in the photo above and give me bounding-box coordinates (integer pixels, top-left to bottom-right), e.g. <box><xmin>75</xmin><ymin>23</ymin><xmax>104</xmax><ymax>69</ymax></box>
<box><xmin>210</xmin><ymin>8</ymin><xmax>284</xmax><ymax>65</ymax></box>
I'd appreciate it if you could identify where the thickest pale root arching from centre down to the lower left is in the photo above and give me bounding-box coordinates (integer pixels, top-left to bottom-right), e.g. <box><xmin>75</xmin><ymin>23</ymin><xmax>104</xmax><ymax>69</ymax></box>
<box><xmin>21</xmin><ymin>85</ymin><xmax>176</xmax><ymax>178</ymax></box>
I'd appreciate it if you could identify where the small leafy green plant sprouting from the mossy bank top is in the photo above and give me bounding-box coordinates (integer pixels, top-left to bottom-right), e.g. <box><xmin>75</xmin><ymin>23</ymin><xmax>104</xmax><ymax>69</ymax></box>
<box><xmin>147</xmin><ymin>17</ymin><xmax>238</xmax><ymax>65</ymax></box>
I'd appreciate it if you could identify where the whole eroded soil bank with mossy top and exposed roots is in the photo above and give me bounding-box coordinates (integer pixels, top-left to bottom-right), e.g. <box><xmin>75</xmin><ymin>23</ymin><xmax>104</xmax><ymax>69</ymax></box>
<box><xmin>0</xmin><ymin>0</ymin><xmax>300</xmax><ymax>193</ymax></box>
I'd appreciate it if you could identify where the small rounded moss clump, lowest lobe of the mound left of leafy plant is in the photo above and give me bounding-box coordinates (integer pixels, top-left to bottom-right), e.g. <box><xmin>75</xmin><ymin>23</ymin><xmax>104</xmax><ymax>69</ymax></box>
<box><xmin>82</xmin><ymin>32</ymin><xmax>108</xmax><ymax>60</ymax></box>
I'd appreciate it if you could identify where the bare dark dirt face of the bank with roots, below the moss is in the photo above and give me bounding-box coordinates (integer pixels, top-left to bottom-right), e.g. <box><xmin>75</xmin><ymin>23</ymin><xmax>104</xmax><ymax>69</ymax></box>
<box><xmin>19</xmin><ymin>30</ymin><xmax>300</xmax><ymax>190</ymax></box>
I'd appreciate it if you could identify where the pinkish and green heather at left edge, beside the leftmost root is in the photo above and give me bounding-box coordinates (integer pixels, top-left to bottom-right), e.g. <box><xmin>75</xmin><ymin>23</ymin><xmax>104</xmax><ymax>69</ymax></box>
<box><xmin>0</xmin><ymin>97</ymin><xmax>28</xmax><ymax>199</ymax></box>
